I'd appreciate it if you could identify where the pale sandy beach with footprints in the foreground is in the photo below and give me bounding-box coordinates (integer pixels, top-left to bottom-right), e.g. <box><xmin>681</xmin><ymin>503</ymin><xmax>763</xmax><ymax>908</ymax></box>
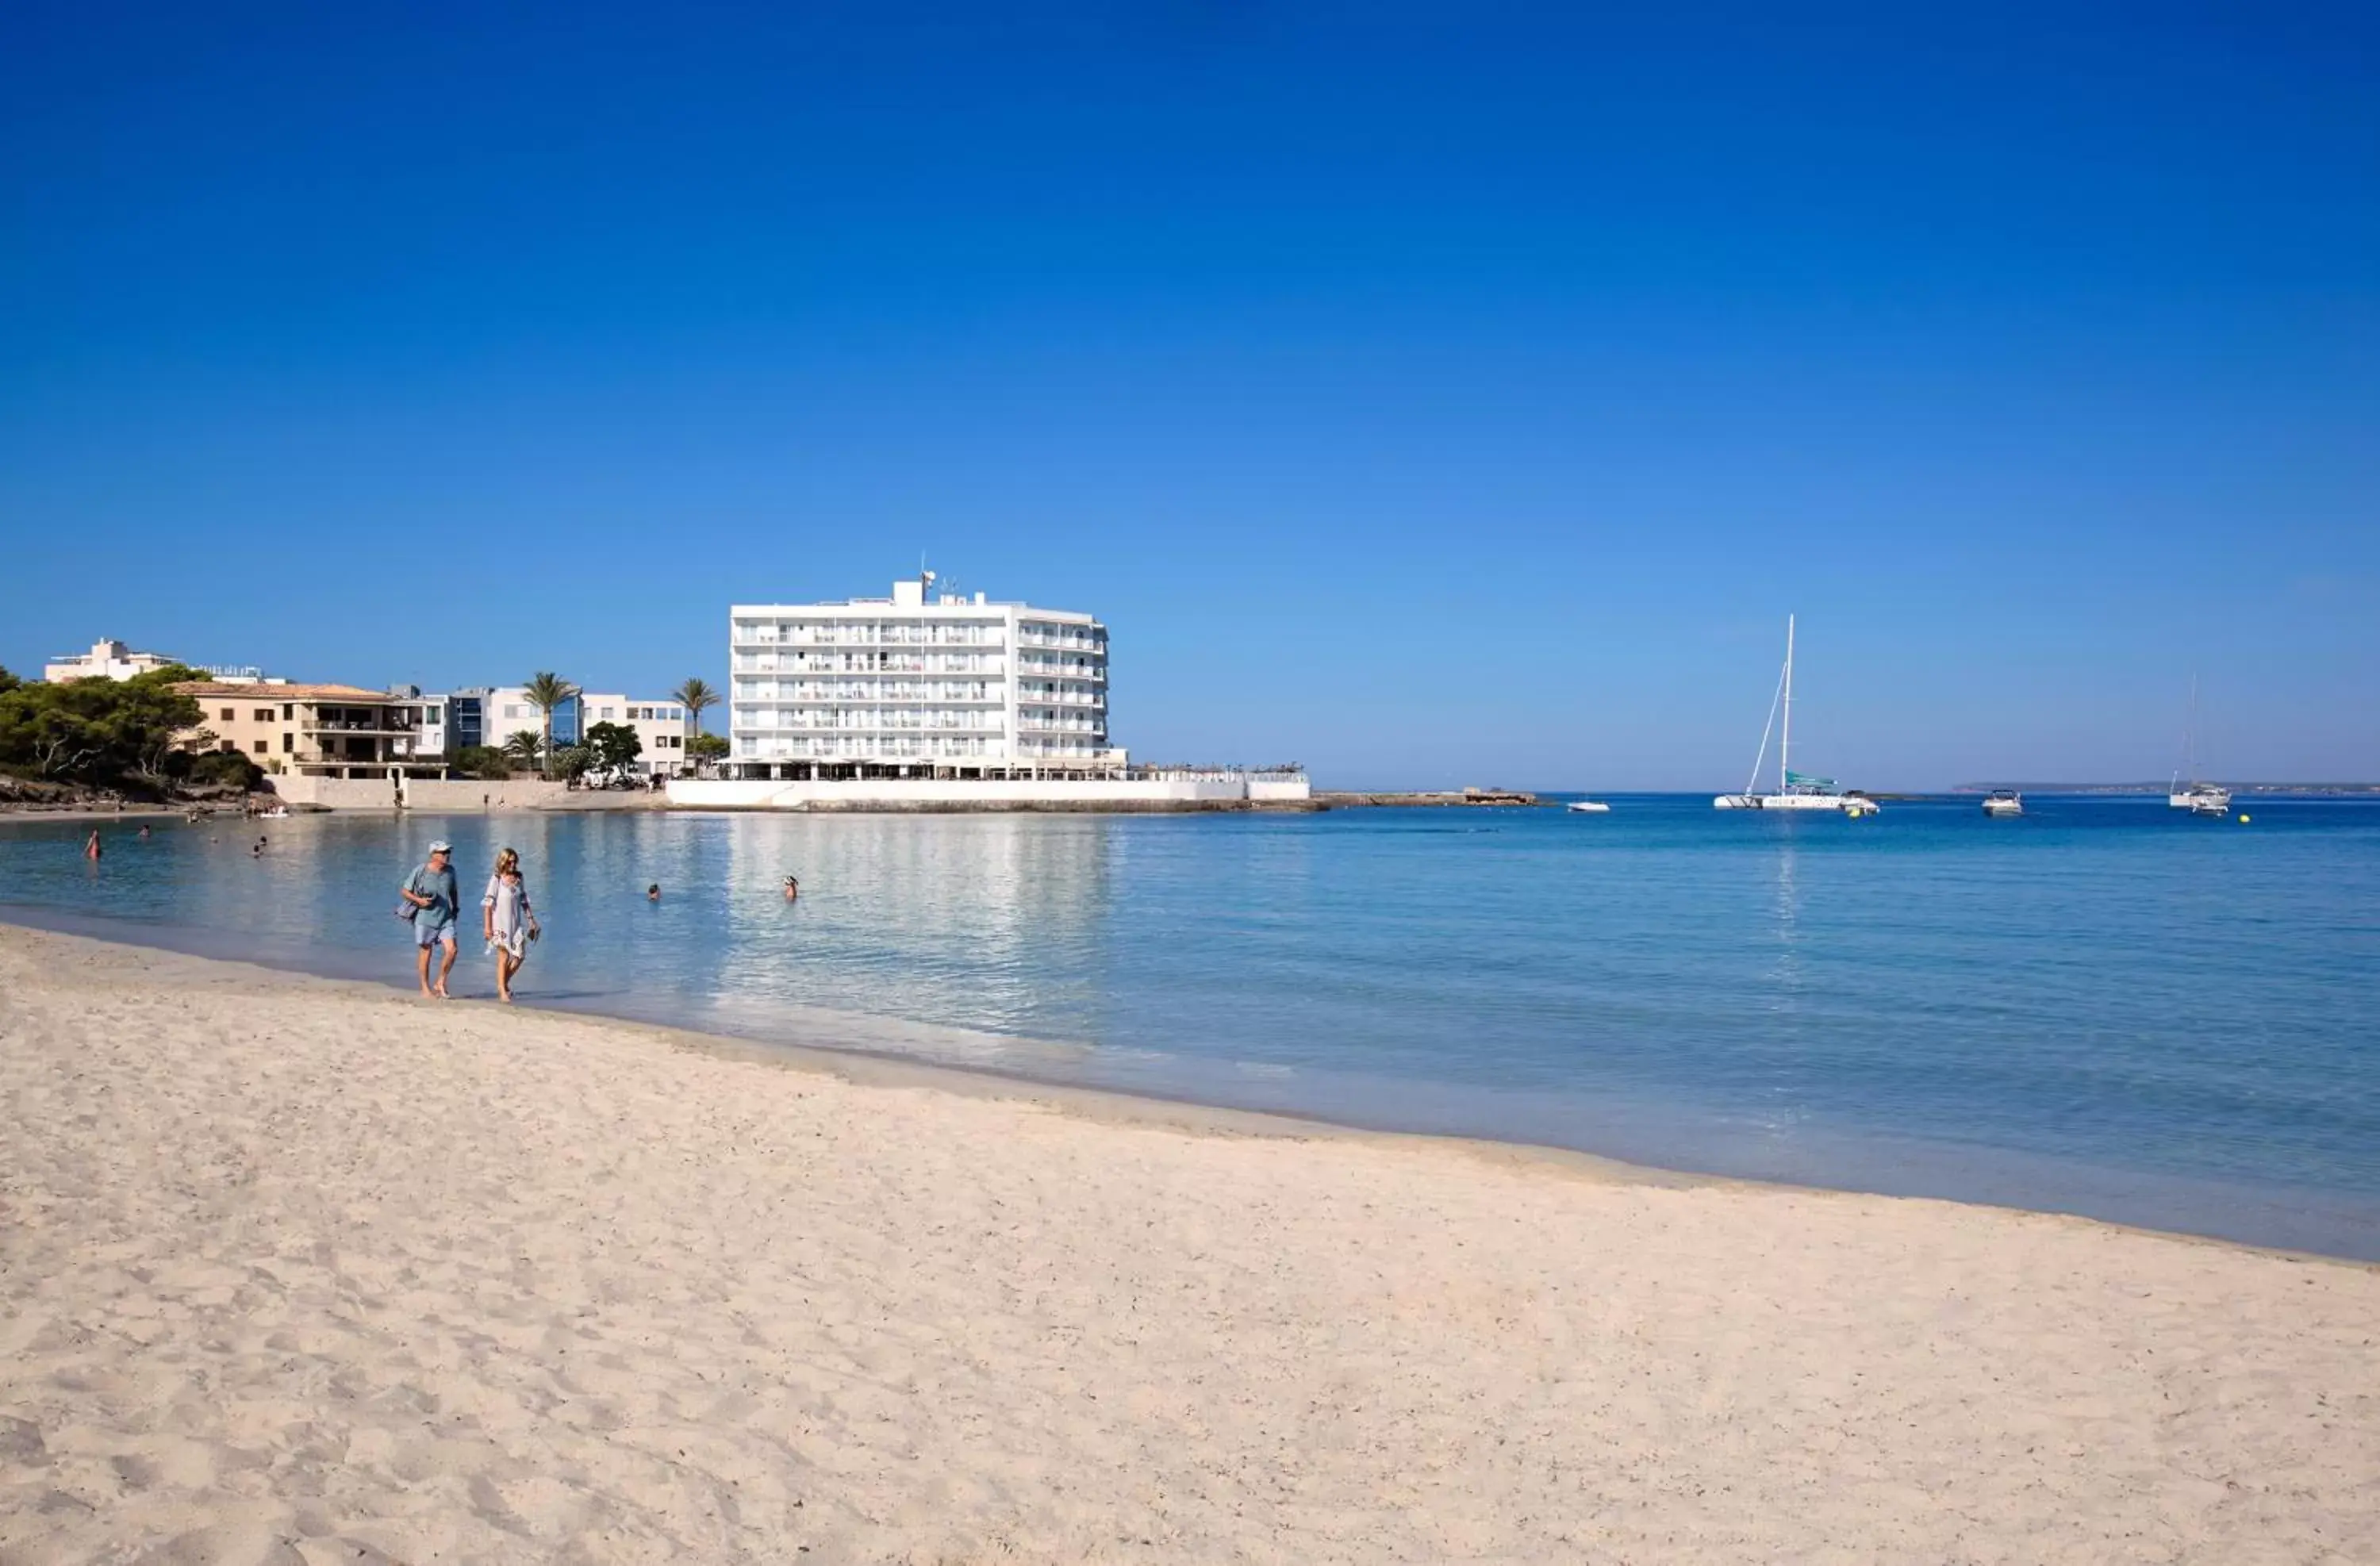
<box><xmin>0</xmin><ymin>931</ymin><xmax>2380</xmax><ymax>1564</ymax></box>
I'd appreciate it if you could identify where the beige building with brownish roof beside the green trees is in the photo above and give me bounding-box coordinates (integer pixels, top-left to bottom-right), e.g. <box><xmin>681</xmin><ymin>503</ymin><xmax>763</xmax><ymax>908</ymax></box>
<box><xmin>174</xmin><ymin>681</ymin><xmax>445</xmax><ymax>778</ymax></box>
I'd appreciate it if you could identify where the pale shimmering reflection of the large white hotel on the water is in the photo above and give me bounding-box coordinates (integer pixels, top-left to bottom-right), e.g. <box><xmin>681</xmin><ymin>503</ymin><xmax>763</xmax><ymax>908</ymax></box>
<box><xmin>704</xmin><ymin>814</ymin><xmax>1123</xmax><ymax>1038</ymax></box>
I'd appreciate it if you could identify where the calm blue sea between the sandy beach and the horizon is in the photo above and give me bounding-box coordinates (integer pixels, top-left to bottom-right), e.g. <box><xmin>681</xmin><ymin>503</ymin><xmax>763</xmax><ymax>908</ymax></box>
<box><xmin>0</xmin><ymin>795</ymin><xmax>2380</xmax><ymax>1259</ymax></box>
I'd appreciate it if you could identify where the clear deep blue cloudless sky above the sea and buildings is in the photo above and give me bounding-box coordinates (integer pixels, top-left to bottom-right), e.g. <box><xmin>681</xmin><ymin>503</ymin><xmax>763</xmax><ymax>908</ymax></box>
<box><xmin>0</xmin><ymin>0</ymin><xmax>2380</xmax><ymax>790</ymax></box>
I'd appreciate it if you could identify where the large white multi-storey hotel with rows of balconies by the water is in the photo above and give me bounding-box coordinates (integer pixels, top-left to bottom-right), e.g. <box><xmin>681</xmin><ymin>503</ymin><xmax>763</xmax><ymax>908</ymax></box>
<box><xmin>728</xmin><ymin>574</ymin><xmax>1126</xmax><ymax>778</ymax></box>
